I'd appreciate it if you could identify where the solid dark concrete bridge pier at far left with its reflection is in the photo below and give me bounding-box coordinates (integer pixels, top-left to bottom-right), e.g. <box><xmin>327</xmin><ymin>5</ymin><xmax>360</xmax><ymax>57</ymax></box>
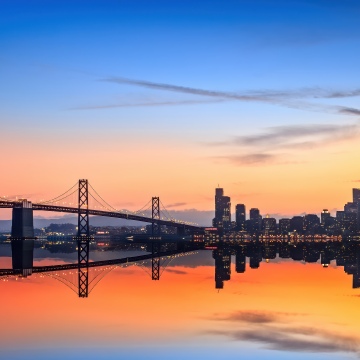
<box><xmin>10</xmin><ymin>199</ymin><xmax>35</xmax><ymax>276</ymax></box>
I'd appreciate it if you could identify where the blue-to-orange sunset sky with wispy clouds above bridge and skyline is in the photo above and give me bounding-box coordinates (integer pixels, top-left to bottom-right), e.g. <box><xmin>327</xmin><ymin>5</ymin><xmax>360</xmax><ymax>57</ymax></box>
<box><xmin>0</xmin><ymin>0</ymin><xmax>360</xmax><ymax>219</ymax></box>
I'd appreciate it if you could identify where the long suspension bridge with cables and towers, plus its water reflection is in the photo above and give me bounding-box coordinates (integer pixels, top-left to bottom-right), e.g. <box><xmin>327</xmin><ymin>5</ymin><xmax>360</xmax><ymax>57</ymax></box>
<box><xmin>0</xmin><ymin>179</ymin><xmax>203</xmax><ymax>297</ymax></box>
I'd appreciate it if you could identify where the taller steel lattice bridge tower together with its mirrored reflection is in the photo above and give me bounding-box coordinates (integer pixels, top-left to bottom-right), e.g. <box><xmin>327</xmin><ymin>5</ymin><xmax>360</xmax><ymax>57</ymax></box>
<box><xmin>76</xmin><ymin>179</ymin><xmax>90</xmax><ymax>298</ymax></box>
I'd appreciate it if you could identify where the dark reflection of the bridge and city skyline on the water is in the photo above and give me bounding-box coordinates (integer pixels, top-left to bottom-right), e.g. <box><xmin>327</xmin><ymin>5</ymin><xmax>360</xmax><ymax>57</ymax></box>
<box><xmin>0</xmin><ymin>239</ymin><xmax>360</xmax><ymax>297</ymax></box>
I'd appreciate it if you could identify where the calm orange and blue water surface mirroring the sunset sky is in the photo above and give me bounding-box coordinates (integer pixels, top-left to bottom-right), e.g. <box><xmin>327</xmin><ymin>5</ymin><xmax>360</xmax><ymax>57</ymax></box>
<box><xmin>0</xmin><ymin>242</ymin><xmax>360</xmax><ymax>359</ymax></box>
